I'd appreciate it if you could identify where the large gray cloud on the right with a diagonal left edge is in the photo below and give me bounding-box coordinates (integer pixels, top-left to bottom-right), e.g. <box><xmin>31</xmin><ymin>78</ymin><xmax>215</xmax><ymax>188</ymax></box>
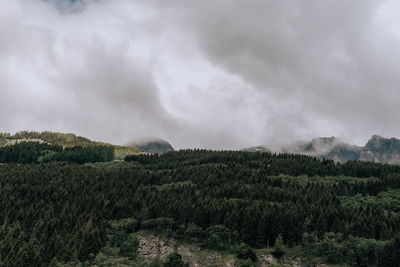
<box><xmin>144</xmin><ymin>0</ymin><xmax>400</xmax><ymax>147</ymax></box>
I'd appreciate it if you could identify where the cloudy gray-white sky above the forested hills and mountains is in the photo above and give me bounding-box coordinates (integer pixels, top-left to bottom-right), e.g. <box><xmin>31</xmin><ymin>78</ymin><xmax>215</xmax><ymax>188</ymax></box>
<box><xmin>0</xmin><ymin>0</ymin><xmax>400</xmax><ymax>149</ymax></box>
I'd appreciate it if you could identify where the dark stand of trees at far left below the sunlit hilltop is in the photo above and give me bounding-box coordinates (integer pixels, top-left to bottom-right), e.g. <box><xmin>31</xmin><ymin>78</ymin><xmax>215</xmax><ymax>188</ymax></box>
<box><xmin>0</xmin><ymin>142</ymin><xmax>114</xmax><ymax>164</ymax></box>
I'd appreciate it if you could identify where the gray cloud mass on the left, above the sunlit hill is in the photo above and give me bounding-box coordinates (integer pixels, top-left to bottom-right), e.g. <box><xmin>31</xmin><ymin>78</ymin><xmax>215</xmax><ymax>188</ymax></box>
<box><xmin>0</xmin><ymin>1</ymin><xmax>176</xmax><ymax>142</ymax></box>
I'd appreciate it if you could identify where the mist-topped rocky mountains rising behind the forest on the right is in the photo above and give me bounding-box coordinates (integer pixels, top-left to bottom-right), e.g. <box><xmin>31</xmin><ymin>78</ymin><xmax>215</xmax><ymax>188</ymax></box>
<box><xmin>244</xmin><ymin>135</ymin><xmax>400</xmax><ymax>164</ymax></box>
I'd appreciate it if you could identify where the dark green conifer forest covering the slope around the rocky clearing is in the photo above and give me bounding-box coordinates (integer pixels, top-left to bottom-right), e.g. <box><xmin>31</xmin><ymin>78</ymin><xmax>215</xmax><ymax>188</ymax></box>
<box><xmin>0</xmin><ymin>148</ymin><xmax>400</xmax><ymax>267</ymax></box>
